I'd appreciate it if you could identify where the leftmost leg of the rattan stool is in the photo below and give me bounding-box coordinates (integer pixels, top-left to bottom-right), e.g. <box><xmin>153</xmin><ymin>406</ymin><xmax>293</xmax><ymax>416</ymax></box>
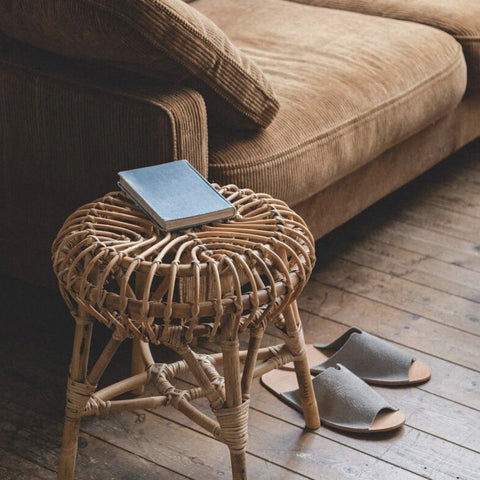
<box><xmin>57</xmin><ymin>312</ymin><xmax>93</xmax><ymax>480</ymax></box>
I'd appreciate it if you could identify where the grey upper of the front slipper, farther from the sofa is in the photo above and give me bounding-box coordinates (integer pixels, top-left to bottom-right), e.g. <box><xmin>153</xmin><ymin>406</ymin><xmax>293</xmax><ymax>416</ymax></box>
<box><xmin>284</xmin><ymin>365</ymin><xmax>398</xmax><ymax>430</ymax></box>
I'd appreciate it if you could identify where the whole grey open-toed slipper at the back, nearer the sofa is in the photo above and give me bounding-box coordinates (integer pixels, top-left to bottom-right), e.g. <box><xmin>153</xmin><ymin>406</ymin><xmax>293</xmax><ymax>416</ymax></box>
<box><xmin>282</xmin><ymin>327</ymin><xmax>432</xmax><ymax>386</ymax></box>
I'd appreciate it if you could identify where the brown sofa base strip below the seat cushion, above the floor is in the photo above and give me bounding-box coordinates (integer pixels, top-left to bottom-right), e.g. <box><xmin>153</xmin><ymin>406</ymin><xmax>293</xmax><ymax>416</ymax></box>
<box><xmin>294</xmin><ymin>94</ymin><xmax>480</xmax><ymax>238</ymax></box>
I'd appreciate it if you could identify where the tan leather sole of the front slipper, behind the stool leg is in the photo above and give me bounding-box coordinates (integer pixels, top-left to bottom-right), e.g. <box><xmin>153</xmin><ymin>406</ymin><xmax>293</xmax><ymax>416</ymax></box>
<box><xmin>261</xmin><ymin>369</ymin><xmax>405</xmax><ymax>433</ymax></box>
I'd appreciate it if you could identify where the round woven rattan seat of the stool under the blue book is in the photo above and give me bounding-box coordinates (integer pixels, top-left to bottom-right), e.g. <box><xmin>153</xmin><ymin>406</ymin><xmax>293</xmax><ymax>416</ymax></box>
<box><xmin>52</xmin><ymin>185</ymin><xmax>314</xmax><ymax>343</ymax></box>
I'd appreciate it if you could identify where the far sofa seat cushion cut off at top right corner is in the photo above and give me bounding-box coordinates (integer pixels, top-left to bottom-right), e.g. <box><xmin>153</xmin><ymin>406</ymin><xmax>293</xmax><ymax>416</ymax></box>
<box><xmin>290</xmin><ymin>0</ymin><xmax>480</xmax><ymax>92</ymax></box>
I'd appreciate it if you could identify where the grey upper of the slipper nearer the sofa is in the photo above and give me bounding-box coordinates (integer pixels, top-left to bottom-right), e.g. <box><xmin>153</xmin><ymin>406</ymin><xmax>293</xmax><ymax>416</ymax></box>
<box><xmin>311</xmin><ymin>328</ymin><xmax>415</xmax><ymax>383</ymax></box>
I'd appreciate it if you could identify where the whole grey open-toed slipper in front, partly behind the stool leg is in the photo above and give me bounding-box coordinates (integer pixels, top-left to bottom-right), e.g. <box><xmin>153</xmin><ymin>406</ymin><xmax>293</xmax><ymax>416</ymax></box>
<box><xmin>261</xmin><ymin>365</ymin><xmax>405</xmax><ymax>433</ymax></box>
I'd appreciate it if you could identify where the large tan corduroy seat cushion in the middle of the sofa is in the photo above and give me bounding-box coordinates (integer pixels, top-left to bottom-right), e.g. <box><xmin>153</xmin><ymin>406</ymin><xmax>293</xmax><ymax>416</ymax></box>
<box><xmin>191</xmin><ymin>0</ymin><xmax>466</xmax><ymax>205</ymax></box>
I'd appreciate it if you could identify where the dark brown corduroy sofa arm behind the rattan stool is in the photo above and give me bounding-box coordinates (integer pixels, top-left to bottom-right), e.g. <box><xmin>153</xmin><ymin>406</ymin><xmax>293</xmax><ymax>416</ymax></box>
<box><xmin>0</xmin><ymin>38</ymin><xmax>208</xmax><ymax>285</ymax></box>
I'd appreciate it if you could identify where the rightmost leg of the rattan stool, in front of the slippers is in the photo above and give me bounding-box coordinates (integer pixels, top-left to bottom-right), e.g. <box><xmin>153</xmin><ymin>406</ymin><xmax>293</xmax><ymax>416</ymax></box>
<box><xmin>284</xmin><ymin>301</ymin><xmax>320</xmax><ymax>430</ymax></box>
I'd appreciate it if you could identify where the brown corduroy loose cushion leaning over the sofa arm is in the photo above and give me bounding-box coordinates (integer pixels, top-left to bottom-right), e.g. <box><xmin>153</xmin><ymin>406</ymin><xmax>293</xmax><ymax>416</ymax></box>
<box><xmin>0</xmin><ymin>0</ymin><xmax>278</xmax><ymax>128</ymax></box>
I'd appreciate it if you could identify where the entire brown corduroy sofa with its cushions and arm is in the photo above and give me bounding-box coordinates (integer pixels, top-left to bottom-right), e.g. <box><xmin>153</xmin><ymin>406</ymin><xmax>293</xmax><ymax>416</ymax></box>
<box><xmin>0</xmin><ymin>0</ymin><xmax>480</xmax><ymax>285</ymax></box>
